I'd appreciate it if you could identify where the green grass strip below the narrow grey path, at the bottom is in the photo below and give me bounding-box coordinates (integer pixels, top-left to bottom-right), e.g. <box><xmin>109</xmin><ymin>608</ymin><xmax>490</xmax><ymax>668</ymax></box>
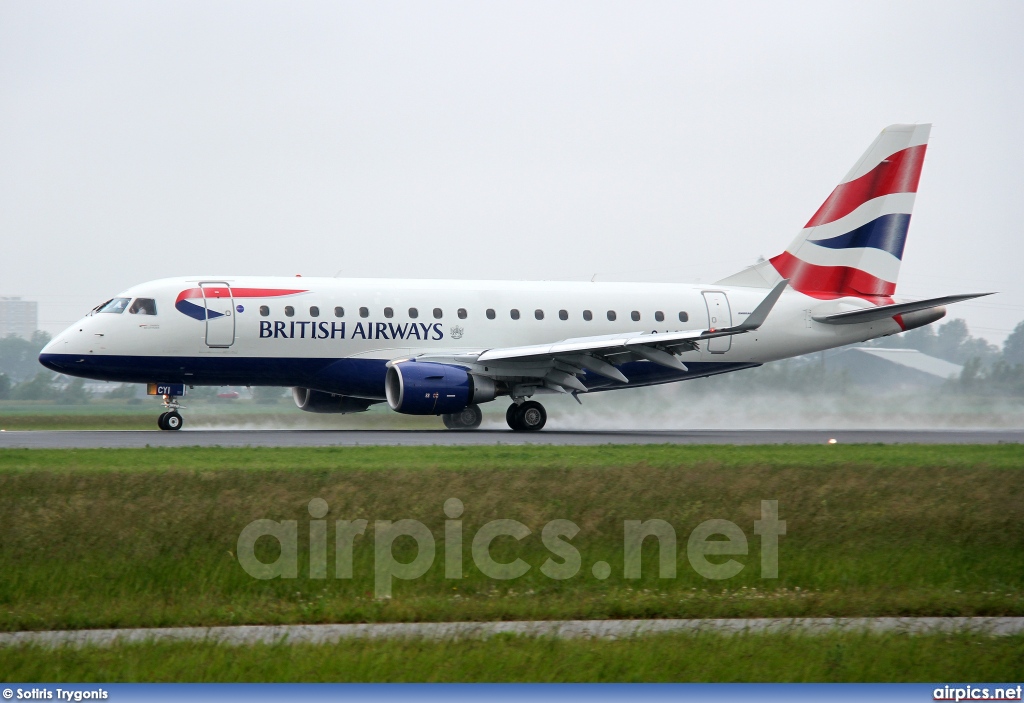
<box><xmin>0</xmin><ymin>633</ymin><xmax>1024</xmax><ymax>683</ymax></box>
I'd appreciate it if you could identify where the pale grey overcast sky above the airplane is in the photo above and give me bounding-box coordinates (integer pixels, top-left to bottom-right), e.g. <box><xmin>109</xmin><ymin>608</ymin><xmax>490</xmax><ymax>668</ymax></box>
<box><xmin>0</xmin><ymin>0</ymin><xmax>1024</xmax><ymax>342</ymax></box>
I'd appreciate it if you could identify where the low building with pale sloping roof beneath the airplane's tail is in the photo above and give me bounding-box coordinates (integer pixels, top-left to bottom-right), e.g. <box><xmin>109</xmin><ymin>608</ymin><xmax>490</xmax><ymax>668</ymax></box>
<box><xmin>825</xmin><ymin>347</ymin><xmax>964</xmax><ymax>389</ymax></box>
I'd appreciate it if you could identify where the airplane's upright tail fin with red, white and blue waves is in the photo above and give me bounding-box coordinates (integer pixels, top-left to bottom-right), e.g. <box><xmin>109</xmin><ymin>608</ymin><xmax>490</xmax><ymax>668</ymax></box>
<box><xmin>719</xmin><ymin>125</ymin><xmax>931</xmax><ymax>298</ymax></box>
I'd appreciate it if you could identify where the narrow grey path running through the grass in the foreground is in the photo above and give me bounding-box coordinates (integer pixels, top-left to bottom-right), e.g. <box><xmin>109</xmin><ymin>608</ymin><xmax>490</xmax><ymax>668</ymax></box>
<box><xmin>0</xmin><ymin>617</ymin><xmax>1024</xmax><ymax>647</ymax></box>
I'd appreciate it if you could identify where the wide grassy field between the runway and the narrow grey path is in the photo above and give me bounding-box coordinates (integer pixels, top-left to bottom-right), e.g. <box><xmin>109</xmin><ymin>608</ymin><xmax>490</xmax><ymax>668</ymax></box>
<box><xmin>0</xmin><ymin>445</ymin><xmax>1024</xmax><ymax>630</ymax></box>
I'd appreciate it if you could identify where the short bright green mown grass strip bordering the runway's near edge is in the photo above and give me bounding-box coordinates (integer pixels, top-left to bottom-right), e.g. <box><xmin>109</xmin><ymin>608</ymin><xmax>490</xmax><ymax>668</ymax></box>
<box><xmin>0</xmin><ymin>444</ymin><xmax>1024</xmax><ymax>472</ymax></box>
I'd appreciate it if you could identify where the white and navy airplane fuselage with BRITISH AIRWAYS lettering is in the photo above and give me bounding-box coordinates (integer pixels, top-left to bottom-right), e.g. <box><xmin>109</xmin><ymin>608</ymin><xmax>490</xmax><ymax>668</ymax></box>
<box><xmin>40</xmin><ymin>276</ymin><xmax>901</xmax><ymax>400</ymax></box>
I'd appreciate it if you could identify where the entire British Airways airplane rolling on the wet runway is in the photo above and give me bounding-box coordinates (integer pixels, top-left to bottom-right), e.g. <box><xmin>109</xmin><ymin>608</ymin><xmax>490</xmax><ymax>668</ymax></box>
<box><xmin>39</xmin><ymin>125</ymin><xmax>989</xmax><ymax>431</ymax></box>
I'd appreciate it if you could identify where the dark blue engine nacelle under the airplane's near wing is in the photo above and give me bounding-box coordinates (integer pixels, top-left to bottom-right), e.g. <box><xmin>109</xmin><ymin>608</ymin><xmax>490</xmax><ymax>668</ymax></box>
<box><xmin>384</xmin><ymin>361</ymin><xmax>498</xmax><ymax>415</ymax></box>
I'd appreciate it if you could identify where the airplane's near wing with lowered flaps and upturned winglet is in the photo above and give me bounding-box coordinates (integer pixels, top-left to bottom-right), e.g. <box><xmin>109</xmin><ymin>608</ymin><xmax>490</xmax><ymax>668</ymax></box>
<box><xmin>403</xmin><ymin>280</ymin><xmax>790</xmax><ymax>393</ymax></box>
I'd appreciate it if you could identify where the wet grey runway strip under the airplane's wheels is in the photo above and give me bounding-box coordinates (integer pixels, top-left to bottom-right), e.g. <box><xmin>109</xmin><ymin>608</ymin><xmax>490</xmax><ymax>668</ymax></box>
<box><xmin>0</xmin><ymin>430</ymin><xmax>1024</xmax><ymax>449</ymax></box>
